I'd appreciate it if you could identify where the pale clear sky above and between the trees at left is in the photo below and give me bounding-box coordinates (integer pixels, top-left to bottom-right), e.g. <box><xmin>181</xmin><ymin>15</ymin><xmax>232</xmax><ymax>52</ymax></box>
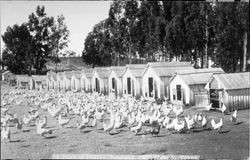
<box><xmin>0</xmin><ymin>1</ymin><xmax>111</xmax><ymax>55</ymax></box>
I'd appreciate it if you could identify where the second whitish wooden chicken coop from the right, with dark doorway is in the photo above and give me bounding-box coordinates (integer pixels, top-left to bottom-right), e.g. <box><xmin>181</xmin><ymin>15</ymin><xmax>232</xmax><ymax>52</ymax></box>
<box><xmin>170</xmin><ymin>68</ymin><xmax>224</xmax><ymax>107</ymax></box>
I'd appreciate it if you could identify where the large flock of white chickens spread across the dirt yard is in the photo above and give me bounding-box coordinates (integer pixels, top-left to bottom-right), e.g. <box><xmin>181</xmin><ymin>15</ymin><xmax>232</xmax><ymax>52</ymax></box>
<box><xmin>1</xmin><ymin>89</ymin><xmax>237</xmax><ymax>141</ymax></box>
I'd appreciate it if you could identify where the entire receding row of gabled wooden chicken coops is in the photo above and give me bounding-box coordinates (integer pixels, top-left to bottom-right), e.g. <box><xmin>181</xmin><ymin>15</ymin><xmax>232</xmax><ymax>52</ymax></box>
<box><xmin>6</xmin><ymin>62</ymin><xmax>250</xmax><ymax>111</ymax></box>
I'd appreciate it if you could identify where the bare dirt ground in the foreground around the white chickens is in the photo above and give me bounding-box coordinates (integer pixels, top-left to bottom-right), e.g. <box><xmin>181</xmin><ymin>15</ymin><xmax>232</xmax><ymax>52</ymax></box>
<box><xmin>1</xmin><ymin>84</ymin><xmax>249</xmax><ymax>159</ymax></box>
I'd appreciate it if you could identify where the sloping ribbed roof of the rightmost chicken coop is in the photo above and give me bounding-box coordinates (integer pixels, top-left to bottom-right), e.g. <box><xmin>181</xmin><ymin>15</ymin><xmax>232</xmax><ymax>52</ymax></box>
<box><xmin>213</xmin><ymin>72</ymin><xmax>250</xmax><ymax>90</ymax></box>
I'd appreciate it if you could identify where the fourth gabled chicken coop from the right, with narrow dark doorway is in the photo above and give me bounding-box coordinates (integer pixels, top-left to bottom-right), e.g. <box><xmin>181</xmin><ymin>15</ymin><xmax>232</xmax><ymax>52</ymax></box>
<box><xmin>122</xmin><ymin>64</ymin><xmax>146</xmax><ymax>96</ymax></box>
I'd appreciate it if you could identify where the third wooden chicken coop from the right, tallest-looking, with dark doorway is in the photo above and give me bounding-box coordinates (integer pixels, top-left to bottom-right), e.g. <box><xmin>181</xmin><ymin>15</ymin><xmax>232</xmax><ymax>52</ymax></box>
<box><xmin>142</xmin><ymin>62</ymin><xmax>194</xmax><ymax>99</ymax></box>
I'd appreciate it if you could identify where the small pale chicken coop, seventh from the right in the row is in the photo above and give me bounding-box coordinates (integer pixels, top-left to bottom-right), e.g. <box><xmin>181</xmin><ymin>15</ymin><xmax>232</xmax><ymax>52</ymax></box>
<box><xmin>80</xmin><ymin>68</ymin><xmax>94</xmax><ymax>92</ymax></box>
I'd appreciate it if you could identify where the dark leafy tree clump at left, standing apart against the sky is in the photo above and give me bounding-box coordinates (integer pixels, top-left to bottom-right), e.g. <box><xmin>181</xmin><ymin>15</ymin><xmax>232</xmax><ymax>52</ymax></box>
<box><xmin>2</xmin><ymin>6</ymin><xmax>69</xmax><ymax>75</ymax></box>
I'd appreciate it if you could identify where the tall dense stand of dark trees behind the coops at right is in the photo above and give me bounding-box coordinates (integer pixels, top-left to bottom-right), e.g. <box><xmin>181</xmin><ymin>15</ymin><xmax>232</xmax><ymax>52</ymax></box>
<box><xmin>83</xmin><ymin>0</ymin><xmax>249</xmax><ymax>72</ymax></box>
